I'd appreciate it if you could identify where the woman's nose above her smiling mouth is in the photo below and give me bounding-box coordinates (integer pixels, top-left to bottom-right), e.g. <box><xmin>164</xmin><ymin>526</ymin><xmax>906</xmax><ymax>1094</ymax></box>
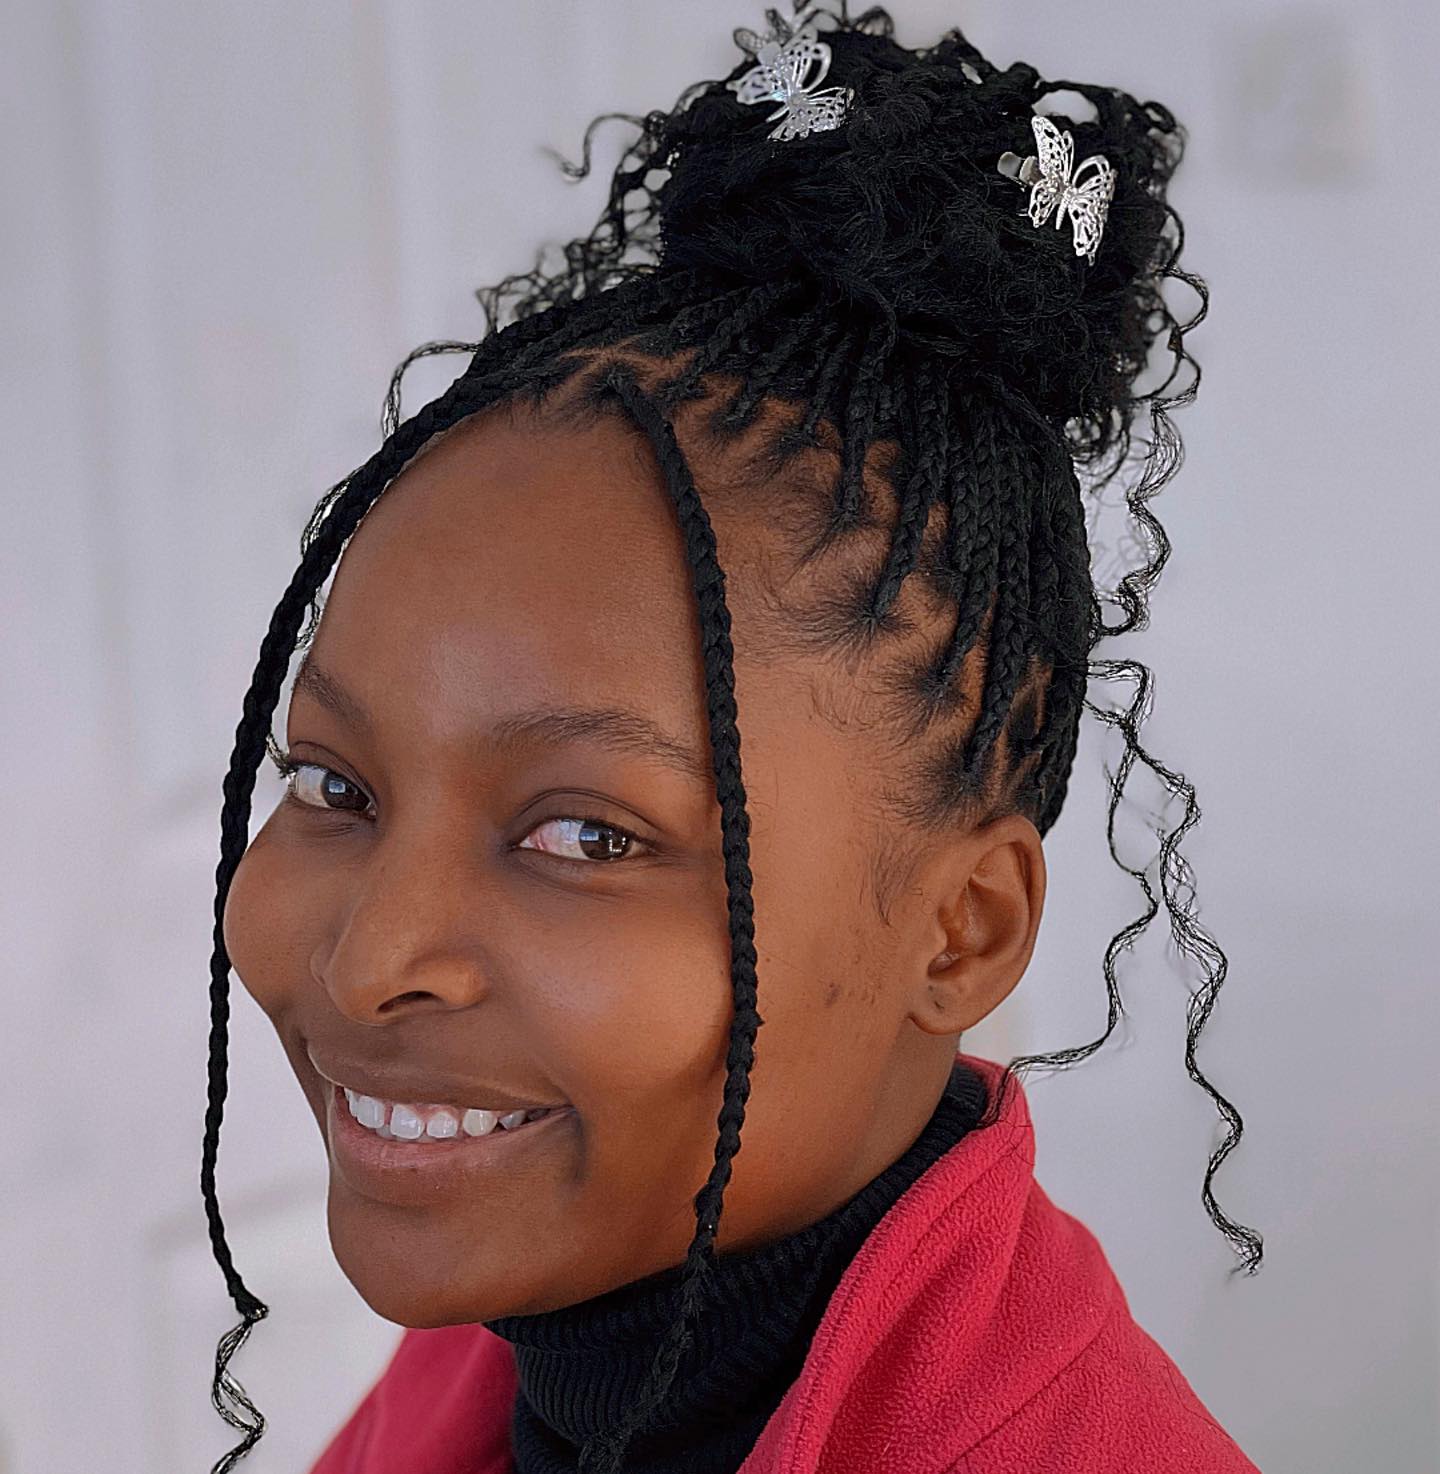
<box><xmin>311</xmin><ymin>834</ymin><xmax>488</xmax><ymax>1023</ymax></box>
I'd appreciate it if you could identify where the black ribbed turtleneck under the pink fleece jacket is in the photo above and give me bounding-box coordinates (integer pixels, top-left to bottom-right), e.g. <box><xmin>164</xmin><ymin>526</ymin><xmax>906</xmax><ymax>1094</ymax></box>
<box><xmin>483</xmin><ymin>1060</ymin><xmax>986</xmax><ymax>1474</ymax></box>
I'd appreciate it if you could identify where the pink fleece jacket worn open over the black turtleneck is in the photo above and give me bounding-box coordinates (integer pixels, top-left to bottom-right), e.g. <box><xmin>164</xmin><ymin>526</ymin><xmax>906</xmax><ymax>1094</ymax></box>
<box><xmin>311</xmin><ymin>1054</ymin><xmax>1259</xmax><ymax>1474</ymax></box>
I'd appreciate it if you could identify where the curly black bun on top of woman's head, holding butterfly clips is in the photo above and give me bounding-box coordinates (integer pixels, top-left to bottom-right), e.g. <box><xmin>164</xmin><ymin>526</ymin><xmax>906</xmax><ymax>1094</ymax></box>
<box><xmin>625</xmin><ymin>10</ymin><xmax>1184</xmax><ymax>455</ymax></box>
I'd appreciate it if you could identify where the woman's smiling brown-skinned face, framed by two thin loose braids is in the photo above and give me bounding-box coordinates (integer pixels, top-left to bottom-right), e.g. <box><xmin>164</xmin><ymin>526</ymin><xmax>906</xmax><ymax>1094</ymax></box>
<box><xmin>224</xmin><ymin>386</ymin><xmax>1039</xmax><ymax>1327</ymax></box>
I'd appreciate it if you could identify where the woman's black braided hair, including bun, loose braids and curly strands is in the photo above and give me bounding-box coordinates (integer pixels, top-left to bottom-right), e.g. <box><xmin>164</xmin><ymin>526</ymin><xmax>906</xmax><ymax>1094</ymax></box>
<box><xmin>200</xmin><ymin>0</ymin><xmax>1262</xmax><ymax>1474</ymax></box>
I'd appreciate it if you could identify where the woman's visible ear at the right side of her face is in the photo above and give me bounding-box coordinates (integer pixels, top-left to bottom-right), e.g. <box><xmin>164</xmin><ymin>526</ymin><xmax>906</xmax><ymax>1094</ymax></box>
<box><xmin>909</xmin><ymin>814</ymin><xmax>1045</xmax><ymax>1035</ymax></box>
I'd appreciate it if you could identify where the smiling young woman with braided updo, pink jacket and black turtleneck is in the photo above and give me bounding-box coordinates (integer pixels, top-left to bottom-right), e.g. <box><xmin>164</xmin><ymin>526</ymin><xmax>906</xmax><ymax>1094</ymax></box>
<box><xmin>202</xmin><ymin>9</ymin><xmax>1260</xmax><ymax>1474</ymax></box>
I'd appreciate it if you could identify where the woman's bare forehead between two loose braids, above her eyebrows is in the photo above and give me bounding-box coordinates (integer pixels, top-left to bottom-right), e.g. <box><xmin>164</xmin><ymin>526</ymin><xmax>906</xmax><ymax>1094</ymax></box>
<box><xmin>315</xmin><ymin>397</ymin><xmax>713</xmax><ymax>725</ymax></box>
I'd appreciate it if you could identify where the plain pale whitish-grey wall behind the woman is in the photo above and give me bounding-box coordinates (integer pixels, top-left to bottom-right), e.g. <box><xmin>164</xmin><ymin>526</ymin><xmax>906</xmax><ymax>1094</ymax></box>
<box><xmin>0</xmin><ymin>0</ymin><xmax>1440</xmax><ymax>1474</ymax></box>
